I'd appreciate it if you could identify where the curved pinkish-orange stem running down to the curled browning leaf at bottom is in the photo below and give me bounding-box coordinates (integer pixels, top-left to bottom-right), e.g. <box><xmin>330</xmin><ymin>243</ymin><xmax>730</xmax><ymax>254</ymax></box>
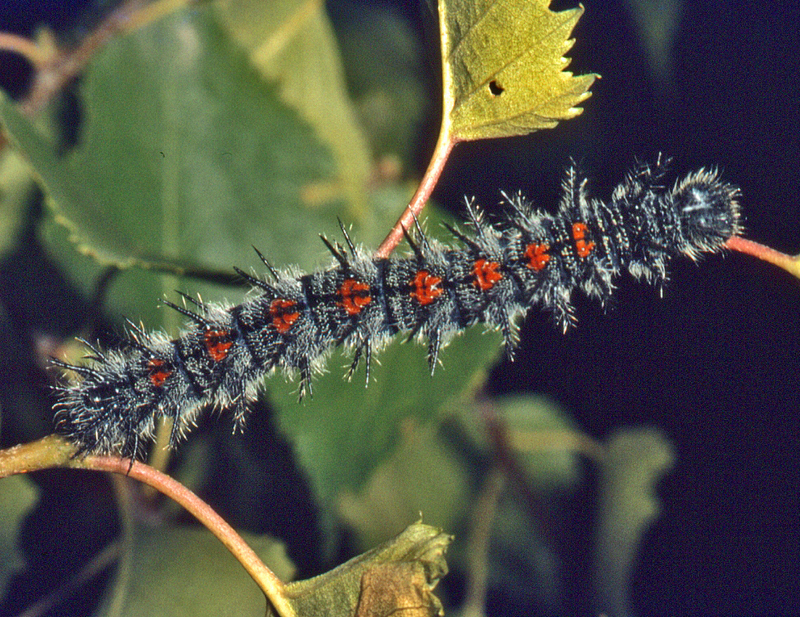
<box><xmin>83</xmin><ymin>456</ymin><xmax>295</xmax><ymax>617</ymax></box>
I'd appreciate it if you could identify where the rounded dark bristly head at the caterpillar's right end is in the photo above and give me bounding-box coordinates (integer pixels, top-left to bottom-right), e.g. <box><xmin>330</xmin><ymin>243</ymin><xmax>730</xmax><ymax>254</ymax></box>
<box><xmin>671</xmin><ymin>169</ymin><xmax>742</xmax><ymax>259</ymax></box>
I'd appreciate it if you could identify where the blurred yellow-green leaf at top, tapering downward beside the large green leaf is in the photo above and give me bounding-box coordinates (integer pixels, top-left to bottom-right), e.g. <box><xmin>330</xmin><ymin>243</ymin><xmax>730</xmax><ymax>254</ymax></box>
<box><xmin>214</xmin><ymin>0</ymin><xmax>371</xmax><ymax>218</ymax></box>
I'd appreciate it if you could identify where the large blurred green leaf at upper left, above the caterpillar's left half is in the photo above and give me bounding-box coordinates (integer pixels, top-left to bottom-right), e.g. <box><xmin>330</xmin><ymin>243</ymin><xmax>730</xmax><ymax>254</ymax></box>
<box><xmin>3</xmin><ymin>7</ymin><xmax>345</xmax><ymax>324</ymax></box>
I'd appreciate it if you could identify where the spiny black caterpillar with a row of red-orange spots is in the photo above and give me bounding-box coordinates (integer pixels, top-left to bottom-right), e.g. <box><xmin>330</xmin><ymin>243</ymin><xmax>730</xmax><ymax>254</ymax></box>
<box><xmin>54</xmin><ymin>159</ymin><xmax>741</xmax><ymax>458</ymax></box>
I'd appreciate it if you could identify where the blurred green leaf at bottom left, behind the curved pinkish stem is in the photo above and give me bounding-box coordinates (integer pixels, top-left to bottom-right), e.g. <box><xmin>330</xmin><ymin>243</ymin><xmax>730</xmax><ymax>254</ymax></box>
<box><xmin>101</xmin><ymin>525</ymin><xmax>294</xmax><ymax>617</ymax></box>
